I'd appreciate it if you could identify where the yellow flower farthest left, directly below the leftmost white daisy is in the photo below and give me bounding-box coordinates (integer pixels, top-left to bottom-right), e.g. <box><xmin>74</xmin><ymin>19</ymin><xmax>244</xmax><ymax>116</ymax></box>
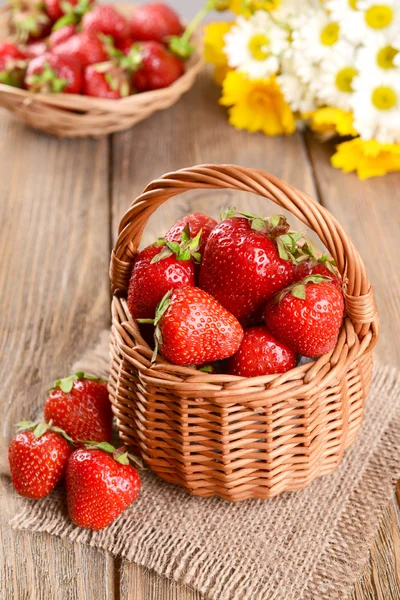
<box><xmin>220</xmin><ymin>71</ymin><xmax>296</xmax><ymax>135</ymax></box>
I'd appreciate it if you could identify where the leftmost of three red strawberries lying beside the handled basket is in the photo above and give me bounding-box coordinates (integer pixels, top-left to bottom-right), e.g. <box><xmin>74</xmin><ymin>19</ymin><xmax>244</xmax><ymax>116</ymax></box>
<box><xmin>8</xmin><ymin>421</ymin><xmax>71</xmax><ymax>498</ymax></box>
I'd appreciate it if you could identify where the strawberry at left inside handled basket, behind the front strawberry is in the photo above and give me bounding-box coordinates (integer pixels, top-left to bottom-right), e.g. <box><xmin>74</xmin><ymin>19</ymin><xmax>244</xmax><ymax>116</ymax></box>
<box><xmin>128</xmin><ymin>235</ymin><xmax>200</xmax><ymax>319</ymax></box>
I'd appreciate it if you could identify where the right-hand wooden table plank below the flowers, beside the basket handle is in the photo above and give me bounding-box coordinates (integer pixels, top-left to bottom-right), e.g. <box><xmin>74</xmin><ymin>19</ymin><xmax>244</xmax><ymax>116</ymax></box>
<box><xmin>306</xmin><ymin>134</ymin><xmax>400</xmax><ymax>367</ymax></box>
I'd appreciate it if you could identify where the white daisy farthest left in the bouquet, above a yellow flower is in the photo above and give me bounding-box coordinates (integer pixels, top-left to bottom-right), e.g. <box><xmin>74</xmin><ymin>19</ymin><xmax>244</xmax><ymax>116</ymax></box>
<box><xmin>224</xmin><ymin>10</ymin><xmax>289</xmax><ymax>79</ymax></box>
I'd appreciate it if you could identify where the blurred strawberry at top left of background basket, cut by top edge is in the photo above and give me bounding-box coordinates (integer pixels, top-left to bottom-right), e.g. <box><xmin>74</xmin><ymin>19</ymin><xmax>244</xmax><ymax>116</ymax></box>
<box><xmin>11</xmin><ymin>0</ymin><xmax>52</xmax><ymax>43</ymax></box>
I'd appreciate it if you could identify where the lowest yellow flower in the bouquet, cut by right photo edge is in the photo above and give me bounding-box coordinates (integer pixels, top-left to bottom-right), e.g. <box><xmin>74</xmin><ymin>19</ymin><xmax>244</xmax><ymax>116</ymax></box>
<box><xmin>331</xmin><ymin>138</ymin><xmax>400</xmax><ymax>179</ymax></box>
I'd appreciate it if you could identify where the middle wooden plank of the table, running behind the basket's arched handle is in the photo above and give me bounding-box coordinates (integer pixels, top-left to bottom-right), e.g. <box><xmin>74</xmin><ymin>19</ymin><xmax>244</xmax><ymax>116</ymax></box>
<box><xmin>112</xmin><ymin>74</ymin><xmax>315</xmax><ymax>600</ymax></box>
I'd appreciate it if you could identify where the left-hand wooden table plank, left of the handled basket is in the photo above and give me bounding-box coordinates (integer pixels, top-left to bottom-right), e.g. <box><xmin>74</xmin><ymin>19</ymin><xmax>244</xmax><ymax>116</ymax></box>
<box><xmin>0</xmin><ymin>112</ymin><xmax>115</xmax><ymax>600</ymax></box>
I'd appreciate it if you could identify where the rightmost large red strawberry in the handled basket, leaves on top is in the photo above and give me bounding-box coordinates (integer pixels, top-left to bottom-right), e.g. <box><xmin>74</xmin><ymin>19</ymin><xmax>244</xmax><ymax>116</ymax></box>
<box><xmin>264</xmin><ymin>275</ymin><xmax>344</xmax><ymax>358</ymax></box>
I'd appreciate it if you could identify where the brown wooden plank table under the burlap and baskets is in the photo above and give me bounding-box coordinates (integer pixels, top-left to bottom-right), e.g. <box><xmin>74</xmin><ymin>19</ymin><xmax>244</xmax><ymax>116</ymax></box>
<box><xmin>0</xmin><ymin>74</ymin><xmax>400</xmax><ymax>600</ymax></box>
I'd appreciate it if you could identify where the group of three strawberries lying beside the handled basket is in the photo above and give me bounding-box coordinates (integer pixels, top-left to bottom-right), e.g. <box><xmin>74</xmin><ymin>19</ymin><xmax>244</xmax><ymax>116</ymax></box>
<box><xmin>8</xmin><ymin>372</ymin><xmax>140</xmax><ymax>530</ymax></box>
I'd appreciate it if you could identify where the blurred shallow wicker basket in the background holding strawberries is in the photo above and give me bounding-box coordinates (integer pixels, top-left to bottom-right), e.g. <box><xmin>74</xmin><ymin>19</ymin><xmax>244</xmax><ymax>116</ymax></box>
<box><xmin>0</xmin><ymin>5</ymin><xmax>203</xmax><ymax>137</ymax></box>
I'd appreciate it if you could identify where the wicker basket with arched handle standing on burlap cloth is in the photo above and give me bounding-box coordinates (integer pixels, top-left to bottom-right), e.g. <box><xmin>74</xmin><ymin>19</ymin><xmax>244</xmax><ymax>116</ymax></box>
<box><xmin>109</xmin><ymin>165</ymin><xmax>379</xmax><ymax>501</ymax></box>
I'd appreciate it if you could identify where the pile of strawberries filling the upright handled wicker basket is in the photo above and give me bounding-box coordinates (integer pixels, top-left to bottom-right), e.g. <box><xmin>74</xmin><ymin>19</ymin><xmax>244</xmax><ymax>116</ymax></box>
<box><xmin>128</xmin><ymin>209</ymin><xmax>344</xmax><ymax>377</ymax></box>
